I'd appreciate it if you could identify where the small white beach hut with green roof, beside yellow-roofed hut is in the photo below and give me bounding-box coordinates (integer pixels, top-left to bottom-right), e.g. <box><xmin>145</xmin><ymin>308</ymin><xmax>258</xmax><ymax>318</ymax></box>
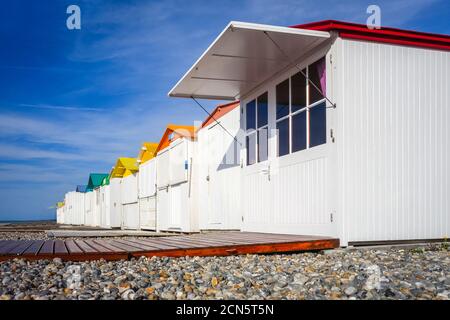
<box><xmin>85</xmin><ymin>173</ymin><xmax>109</xmax><ymax>227</ymax></box>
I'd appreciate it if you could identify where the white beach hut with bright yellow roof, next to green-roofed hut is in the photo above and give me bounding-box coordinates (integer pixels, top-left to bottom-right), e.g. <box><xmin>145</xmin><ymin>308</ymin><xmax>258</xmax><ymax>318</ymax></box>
<box><xmin>110</xmin><ymin>158</ymin><xmax>139</xmax><ymax>230</ymax></box>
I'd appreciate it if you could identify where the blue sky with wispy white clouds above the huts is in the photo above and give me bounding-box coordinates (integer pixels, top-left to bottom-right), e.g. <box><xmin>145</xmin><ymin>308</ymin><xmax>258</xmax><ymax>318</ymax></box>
<box><xmin>0</xmin><ymin>0</ymin><xmax>450</xmax><ymax>220</ymax></box>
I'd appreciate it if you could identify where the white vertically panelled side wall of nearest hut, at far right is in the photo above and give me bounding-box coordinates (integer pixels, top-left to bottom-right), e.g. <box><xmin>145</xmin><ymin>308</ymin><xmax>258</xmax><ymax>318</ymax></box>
<box><xmin>338</xmin><ymin>40</ymin><xmax>450</xmax><ymax>243</ymax></box>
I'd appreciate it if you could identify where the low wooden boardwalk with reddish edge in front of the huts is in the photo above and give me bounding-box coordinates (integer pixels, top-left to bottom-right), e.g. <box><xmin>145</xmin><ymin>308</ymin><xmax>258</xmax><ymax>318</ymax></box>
<box><xmin>0</xmin><ymin>232</ymin><xmax>339</xmax><ymax>261</ymax></box>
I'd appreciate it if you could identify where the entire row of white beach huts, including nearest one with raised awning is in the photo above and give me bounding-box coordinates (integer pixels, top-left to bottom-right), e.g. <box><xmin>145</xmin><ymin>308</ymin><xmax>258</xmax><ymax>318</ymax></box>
<box><xmin>58</xmin><ymin>20</ymin><xmax>450</xmax><ymax>246</ymax></box>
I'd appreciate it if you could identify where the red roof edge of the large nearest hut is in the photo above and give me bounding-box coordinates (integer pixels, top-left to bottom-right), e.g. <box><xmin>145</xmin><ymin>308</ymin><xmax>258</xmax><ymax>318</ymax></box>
<box><xmin>292</xmin><ymin>20</ymin><xmax>450</xmax><ymax>50</ymax></box>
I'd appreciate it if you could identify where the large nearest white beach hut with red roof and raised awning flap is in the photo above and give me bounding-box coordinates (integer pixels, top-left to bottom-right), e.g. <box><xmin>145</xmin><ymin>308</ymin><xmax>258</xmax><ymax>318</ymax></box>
<box><xmin>168</xmin><ymin>21</ymin><xmax>450</xmax><ymax>246</ymax></box>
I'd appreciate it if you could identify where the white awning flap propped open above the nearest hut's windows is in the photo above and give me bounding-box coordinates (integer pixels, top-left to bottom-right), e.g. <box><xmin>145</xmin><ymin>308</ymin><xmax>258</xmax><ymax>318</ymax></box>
<box><xmin>169</xmin><ymin>22</ymin><xmax>330</xmax><ymax>100</ymax></box>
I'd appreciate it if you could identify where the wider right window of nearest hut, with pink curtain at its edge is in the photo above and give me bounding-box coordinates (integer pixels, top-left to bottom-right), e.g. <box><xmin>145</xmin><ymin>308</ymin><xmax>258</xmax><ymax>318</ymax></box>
<box><xmin>276</xmin><ymin>58</ymin><xmax>326</xmax><ymax>157</ymax></box>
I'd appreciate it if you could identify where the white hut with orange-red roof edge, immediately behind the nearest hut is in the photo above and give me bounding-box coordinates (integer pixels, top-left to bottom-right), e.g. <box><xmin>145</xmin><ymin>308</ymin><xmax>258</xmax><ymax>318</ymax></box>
<box><xmin>197</xmin><ymin>101</ymin><xmax>242</xmax><ymax>230</ymax></box>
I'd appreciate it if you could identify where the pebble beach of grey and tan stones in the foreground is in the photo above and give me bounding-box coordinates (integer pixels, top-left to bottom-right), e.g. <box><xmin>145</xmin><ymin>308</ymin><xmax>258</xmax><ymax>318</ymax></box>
<box><xmin>0</xmin><ymin>225</ymin><xmax>450</xmax><ymax>300</ymax></box>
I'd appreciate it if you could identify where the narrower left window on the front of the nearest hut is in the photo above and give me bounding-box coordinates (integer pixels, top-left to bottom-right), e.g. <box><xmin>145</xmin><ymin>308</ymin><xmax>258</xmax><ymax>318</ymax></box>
<box><xmin>245</xmin><ymin>92</ymin><xmax>269</xmax><ymax>165</ymax></box>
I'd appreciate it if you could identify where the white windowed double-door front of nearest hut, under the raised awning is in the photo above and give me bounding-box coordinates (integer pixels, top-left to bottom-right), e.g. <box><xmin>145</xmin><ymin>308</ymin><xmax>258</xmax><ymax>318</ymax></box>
<box><xmin>241</xmin><ymin>70</ymin><xmax>336</xmax><ymax>236</ymax></box>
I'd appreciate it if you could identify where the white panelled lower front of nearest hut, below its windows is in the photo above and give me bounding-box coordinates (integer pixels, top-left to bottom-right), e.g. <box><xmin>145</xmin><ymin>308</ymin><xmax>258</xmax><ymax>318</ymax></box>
<box><xmin>243</xmin><ymin>155</ymin><xmax>331</xmax><ymax>235</ymax></box>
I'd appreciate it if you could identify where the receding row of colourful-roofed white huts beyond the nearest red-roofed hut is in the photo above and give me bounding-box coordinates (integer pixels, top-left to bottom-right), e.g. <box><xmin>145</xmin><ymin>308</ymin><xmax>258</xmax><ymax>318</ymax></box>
<box><xmin>57</xmin><ymin>102</ymin><xmax>240</xmax><ymax>233</ymax></box>
